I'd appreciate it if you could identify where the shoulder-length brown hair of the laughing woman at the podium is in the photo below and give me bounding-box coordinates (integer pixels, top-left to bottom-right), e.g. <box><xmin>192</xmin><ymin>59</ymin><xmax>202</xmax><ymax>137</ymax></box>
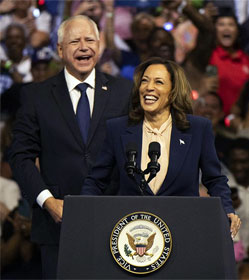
<box><xmin>129</xmin><ymin>57</ymin><xmax>193</xmax><ymax>130</ymax></box>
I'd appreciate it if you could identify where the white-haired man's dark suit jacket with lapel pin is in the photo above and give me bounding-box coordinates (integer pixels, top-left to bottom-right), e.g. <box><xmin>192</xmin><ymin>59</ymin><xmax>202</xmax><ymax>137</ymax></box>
<box><xmin>10</xmin><ymin>71</ymin><xmax>132</xmax><ymax>244</ymax></box>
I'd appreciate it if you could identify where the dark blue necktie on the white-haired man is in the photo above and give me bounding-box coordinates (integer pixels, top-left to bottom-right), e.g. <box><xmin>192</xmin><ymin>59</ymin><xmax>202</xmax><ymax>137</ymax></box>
<box><xmin>76</xmin><ymin>83</ymin><xmax>90</xmax><ymax>144</ymax></box>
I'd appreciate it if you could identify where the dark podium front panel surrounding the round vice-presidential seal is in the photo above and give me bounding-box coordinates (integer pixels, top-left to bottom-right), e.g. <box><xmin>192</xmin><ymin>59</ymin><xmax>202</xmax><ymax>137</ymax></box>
<box><xmin>58</xmin><ymin>196</ymin><xmax>236</xmax><ymax>279</ymax></box>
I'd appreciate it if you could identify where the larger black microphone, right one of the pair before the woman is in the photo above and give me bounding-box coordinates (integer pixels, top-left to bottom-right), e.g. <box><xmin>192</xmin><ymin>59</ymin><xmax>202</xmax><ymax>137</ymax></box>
<box><xmin>147</xmin><ymin>142</ymin><xmax>161</xmax><ymax>183</ymax></box>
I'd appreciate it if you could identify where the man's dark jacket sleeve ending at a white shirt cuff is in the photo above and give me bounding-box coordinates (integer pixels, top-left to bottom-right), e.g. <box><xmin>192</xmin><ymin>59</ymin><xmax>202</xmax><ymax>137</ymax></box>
<box><xmin>10</xmin><ymin>86</ymin><xmax>46</xmax><ymax>205</ymax></box>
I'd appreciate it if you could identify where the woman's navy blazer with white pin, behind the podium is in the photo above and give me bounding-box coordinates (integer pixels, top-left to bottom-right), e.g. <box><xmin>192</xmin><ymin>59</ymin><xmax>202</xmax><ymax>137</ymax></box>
<box><xmin>81</xmin><ymin>115</ymin><xmax>234</xmax><ymax>213</ymax></box>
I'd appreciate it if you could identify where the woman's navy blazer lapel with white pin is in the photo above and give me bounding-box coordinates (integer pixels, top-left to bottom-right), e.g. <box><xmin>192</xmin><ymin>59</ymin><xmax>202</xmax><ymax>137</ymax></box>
<box><xmin>158</xmin><ymin>123</ymin><xmax>192</xmax><ymax>195</ymax></box>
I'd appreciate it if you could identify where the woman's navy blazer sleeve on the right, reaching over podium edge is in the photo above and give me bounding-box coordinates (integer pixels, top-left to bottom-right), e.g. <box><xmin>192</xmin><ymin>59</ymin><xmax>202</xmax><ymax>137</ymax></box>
<box><xmin>200</xmin><ymin>119</ymin><xmax>234</xmax><ymax>213</ymax></box>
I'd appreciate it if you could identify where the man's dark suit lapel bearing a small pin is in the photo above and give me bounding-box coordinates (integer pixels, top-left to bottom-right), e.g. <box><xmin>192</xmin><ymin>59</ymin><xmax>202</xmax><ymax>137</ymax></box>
<box><xmin>87</xmin><ymin>71</ymin><xmax>111</xmax><ymax>145</ymax></box>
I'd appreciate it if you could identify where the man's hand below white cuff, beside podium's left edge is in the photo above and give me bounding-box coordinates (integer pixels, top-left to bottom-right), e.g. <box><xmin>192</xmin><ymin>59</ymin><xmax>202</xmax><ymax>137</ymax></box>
<box><xmin>43</xmin><ymin>197</ymin><xmax>64</xmax><ymax>223</ymax></box>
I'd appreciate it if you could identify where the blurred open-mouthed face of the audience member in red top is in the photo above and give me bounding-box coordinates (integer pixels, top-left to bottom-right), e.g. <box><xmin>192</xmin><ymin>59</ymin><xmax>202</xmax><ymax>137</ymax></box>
<box><xmin>215</xmin><ymin>17</ymin><xmax>238</xmax><ymax>48</ymax></box>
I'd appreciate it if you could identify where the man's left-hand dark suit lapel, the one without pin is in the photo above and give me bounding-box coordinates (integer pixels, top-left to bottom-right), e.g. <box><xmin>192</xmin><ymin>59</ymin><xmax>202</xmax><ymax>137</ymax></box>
<box><xmin>52</xmin><ymin>71</ymin><xmax>84</xmax><ymax>149</ymax></box>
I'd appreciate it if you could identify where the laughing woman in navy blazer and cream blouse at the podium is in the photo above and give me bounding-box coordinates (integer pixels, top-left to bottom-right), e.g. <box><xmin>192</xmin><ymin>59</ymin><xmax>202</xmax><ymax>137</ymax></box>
<box><xmin>82</xmin><ymin>58</ymin><xmax>241</xmax><ymax>237</ymax></box>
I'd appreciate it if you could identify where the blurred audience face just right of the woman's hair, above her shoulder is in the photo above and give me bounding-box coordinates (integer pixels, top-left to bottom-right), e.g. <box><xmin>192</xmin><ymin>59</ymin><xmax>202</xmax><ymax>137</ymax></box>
<box><xmin>194</xmin><ymin>94</ymin><xmax>224</xmax><ymax>129</ymax></box>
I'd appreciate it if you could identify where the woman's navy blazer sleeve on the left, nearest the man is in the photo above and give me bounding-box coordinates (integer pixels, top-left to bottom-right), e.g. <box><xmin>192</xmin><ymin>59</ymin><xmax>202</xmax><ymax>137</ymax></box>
<box><xmin>81</xmin><ymin>122</ymin><xmax>116</xmax><ymax>195</ymax></box>
